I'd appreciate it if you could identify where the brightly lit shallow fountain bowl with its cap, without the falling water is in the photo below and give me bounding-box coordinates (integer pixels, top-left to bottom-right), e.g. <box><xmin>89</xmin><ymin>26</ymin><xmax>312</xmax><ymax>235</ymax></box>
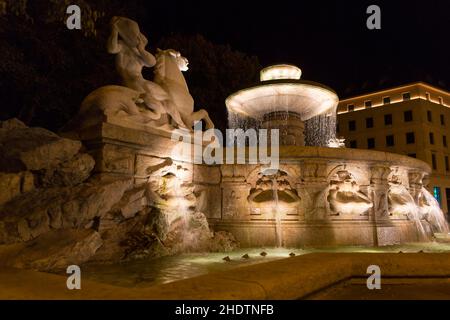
<box><xmin>229</xmin><ymin>65</ymin><xmax>339</xmax><ymax>121</ymax></box>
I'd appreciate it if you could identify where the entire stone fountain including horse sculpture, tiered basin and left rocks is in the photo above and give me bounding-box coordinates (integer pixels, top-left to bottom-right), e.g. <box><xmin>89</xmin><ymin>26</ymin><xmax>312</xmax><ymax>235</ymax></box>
<box><xmin>0</xmin><ymin>17</ymin><xmax>448</xmax><ymax>270</ymax></box>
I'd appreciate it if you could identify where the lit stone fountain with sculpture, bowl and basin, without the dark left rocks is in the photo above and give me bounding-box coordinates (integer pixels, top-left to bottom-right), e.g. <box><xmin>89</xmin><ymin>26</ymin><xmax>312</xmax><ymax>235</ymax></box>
<box><xmin>47</xmin><ymin>18</ymin><xmax>448</xmax><ymax>250</ymax></box>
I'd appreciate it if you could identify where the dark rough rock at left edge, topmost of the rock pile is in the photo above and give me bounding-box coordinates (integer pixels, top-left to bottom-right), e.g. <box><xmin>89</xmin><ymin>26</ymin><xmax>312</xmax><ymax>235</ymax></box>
<box><xmin>0</xmin><ymin>120</ymin><xmax>81</xmax><ymax>172</ymax></box>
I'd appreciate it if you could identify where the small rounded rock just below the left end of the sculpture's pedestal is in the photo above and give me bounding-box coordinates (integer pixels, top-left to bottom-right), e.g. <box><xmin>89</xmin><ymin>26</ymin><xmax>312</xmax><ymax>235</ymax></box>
<box><xmin>39</xmin><ymin>153</ymin><xmax>95</xmax><ymax>187</ymax></box>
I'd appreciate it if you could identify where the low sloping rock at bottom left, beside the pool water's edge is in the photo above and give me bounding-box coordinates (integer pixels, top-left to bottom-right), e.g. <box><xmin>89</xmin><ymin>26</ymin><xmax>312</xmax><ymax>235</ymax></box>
<box><xmin>0</xmin><ymin>229</ymin><xmax>103</xmax><ymax>271</ymax></box>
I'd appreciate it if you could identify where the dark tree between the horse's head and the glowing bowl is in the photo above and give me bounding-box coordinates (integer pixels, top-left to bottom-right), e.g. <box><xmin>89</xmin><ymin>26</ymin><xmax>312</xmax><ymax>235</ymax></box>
<box><xmin>158</xmin><ymin>34</ymin><xmax>261</xmax><ymax>130</ymax></box>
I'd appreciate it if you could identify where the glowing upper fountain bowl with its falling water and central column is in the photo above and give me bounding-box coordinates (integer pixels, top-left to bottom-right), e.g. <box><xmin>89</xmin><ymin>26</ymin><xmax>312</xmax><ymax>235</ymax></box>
<box><xmin>225</xmin><ymin>64</ymin><xmax>339</xmax><ymax>146</ymax></box>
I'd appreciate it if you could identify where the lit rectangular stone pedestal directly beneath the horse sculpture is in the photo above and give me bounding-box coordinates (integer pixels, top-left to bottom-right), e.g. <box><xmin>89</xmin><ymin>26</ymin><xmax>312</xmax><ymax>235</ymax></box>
<box><xmin>64</xmin><ymin>123</ymin><xmax>221</xmax><ymax>218</ymax></box>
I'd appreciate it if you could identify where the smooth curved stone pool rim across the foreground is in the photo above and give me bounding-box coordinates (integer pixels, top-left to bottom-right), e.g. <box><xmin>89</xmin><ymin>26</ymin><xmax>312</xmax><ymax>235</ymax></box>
<box><xmin>0</xmin><ymin>253</ymin><xmax>450</xmax><ymax>299</ymax></box>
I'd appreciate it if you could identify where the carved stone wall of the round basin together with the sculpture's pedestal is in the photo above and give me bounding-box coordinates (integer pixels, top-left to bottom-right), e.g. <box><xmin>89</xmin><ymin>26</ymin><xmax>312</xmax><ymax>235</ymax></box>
<box><xmin>68</xmin><ymin>124</ymin><xmax>439</xmax><ymax>246</ymax></box>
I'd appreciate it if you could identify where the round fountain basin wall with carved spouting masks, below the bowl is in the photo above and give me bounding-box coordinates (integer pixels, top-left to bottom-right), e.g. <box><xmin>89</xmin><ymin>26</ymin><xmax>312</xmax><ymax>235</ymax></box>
<box><xmin>209</xmin><ymin>146</ymin><xmax>448</xmax><ymax>247</ymax></box>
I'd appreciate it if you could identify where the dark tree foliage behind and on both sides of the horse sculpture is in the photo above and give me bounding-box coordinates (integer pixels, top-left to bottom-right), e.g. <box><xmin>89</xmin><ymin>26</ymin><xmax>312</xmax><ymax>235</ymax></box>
<box><xmin>0</xmin><ymin>0</ymin><xmax>259</xmax><ymax>130</ymax></box>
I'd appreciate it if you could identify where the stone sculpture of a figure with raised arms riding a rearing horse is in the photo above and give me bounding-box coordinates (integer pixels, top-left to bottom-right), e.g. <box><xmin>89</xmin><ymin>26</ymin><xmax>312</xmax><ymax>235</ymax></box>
<box><xmin>64</xmin><ymin>17</ymin><xmax>214</xmax><ymax>131</ymax></box>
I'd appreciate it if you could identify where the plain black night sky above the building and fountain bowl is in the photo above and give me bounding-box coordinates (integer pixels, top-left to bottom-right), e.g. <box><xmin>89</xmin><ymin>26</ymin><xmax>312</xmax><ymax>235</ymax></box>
<box><xmin>141</xmin><ymin>0</ymin><xmax>450</xmax><ymax>98</ymax></box>
